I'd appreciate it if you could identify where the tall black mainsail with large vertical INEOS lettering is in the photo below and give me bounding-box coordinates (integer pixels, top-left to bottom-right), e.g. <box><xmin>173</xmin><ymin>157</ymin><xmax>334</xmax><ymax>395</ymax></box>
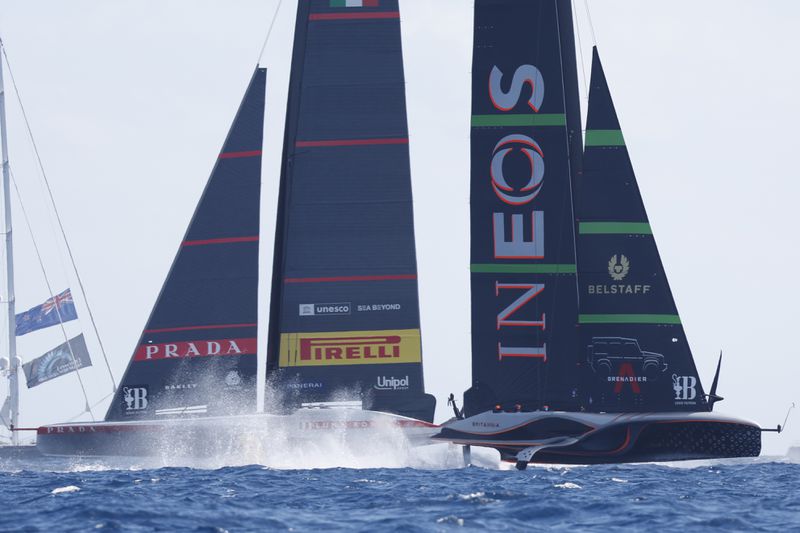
<box><xmin>464</xmin><ymin>0</ymin><xmax>581</xmax><ymax>415</ymax></box>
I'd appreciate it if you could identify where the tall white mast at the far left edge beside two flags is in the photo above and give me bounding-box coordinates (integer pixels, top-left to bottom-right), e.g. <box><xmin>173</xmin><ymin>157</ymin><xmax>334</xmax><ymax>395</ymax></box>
<box><xmin>0</xmin><ymin>41</ymin><xmax>19</xmax><ymax>446</ymax></box>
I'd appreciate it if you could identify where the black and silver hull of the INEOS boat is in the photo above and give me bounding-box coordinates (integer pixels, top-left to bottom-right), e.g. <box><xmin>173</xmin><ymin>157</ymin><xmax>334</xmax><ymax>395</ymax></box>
<box><xmin>434</xmin><ymin>411</ymin><xmax>761</xmax><ymax>468</ymax></box>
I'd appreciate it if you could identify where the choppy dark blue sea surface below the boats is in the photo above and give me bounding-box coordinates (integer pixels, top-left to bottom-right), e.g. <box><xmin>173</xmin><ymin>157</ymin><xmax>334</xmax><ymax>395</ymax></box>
<box><xmin>0</xmin><ymin>458</ymin><xmax>800</xmax><ymax>531</ymax></box>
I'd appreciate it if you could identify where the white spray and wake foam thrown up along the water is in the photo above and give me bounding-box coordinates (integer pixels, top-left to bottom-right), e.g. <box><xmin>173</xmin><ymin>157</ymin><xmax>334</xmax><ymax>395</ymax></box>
<box><xmin>9</xmin><ymin>409</ymin><xmax>500</xmax><ymax>472</ymax></box>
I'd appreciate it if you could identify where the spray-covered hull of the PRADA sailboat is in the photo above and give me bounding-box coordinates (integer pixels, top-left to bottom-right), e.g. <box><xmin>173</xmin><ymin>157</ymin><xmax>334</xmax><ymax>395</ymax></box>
<box><xmin>36</xmin><ymin>409</ymin><xmax>438</xmax><ymax>458</ymax></box>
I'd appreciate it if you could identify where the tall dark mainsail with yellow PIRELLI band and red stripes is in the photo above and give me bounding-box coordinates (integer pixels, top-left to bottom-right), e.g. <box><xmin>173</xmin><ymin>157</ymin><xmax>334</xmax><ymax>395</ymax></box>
<box><xmin>266</xmin><ymin>0</ymin><xmax>435</xmax><ymax>421</ymax></box>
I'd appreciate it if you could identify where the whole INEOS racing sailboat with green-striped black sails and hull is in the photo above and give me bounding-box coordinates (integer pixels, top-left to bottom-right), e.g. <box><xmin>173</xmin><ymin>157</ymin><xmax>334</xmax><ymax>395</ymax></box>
<box><xmin>435</xmin><ymin>0</ymin><xmax>761</xmax><ymax>469</ymax></box>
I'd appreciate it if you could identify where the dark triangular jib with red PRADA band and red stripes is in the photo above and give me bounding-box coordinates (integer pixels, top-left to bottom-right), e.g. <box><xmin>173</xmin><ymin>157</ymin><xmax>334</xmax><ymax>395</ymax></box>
<box><xmin>106</xmin><ymin>69</ymin><xmax>266</xmax><ymax>420</ymax></box>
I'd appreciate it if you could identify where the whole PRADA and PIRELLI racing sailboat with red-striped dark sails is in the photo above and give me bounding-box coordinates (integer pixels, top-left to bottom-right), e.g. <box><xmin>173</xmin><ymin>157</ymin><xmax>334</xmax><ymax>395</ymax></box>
<box><xmin>37</xmin><ymin>0</ymin><xmax>437</xmax><ymax>456</ymax></box>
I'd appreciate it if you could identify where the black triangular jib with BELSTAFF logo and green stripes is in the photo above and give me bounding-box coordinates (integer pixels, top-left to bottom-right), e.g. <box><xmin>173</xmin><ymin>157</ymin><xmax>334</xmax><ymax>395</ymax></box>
<box><xmin>576</xmin><ymin>48</ymin><xmax>708</xmax><ymax>412</ymax></box>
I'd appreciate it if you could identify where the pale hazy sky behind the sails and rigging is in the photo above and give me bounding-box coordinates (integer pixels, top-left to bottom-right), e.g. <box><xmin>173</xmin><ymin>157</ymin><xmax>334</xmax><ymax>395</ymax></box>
<box><xmin>0</xmin><ymin>0</ymin><xmax>800</xmax><ymax>453</ymax></box>
